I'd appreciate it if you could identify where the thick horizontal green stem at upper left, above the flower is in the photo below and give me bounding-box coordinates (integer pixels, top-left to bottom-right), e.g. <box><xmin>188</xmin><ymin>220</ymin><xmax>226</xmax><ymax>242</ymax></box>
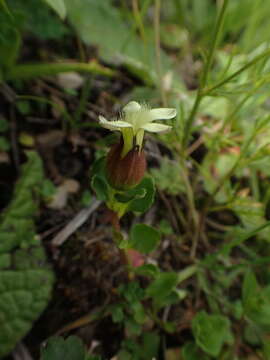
<box><xmin>4</xmin><ymin>61</ymin><xmax>116</xmax><ymax>80</ymax></box>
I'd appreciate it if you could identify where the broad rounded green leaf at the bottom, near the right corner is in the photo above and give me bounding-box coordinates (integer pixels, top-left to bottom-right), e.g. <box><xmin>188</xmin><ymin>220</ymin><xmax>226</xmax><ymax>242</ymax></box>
<box><xmin>192</xmin><ymin>311</ymin><xmax>231</xmax><ymax>356</ymax></box>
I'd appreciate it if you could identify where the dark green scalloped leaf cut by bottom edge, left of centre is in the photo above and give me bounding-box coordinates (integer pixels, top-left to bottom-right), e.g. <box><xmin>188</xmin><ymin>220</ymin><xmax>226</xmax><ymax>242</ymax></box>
<box><xmin>41</xmin><ymin>336</ymin><xmax>86</xmax><ymax>360</ymax></box>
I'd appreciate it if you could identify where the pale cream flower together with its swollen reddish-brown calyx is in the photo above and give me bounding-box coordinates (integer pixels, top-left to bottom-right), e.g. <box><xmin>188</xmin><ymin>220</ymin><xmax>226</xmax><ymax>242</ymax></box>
<box><xmin>99</xmin><ymin>101</ymin><xmax>176</xmax><ymax>190</ymax></box>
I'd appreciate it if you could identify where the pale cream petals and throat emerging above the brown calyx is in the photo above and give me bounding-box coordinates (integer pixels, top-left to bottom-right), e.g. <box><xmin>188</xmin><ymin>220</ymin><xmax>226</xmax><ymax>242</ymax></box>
<box><xmin>99</xmin><ymin>101</ymin><xmax>176</xmax><ymax>158</ymax></box>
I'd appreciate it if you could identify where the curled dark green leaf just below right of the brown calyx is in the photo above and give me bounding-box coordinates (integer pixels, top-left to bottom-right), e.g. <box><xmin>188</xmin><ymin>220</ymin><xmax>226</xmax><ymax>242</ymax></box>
<box><xmin>128</xmin><ymin>177</ymin><xmax>155</xmax><ymax>213</ymax></box>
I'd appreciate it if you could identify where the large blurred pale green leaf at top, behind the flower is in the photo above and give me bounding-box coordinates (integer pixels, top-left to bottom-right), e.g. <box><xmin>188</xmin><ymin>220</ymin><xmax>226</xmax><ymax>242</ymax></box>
<box><xmin>65</xmin><ymin>0</ymin><xmax>171</xmax><ymax>84</ymax></box>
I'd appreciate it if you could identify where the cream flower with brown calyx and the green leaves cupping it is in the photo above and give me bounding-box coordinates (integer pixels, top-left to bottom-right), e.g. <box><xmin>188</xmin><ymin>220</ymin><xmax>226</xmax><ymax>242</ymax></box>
<box><xmin>92</xmin><ymin>101</ymin><xmax>176</xmax><ymax>219</ymax></box>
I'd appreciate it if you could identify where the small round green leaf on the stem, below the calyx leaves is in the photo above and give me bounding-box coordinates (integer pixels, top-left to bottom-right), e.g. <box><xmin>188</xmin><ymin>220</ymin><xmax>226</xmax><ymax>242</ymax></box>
<box><xmin>130</xmin><ymin>224</ymin><xmax>160</xmax><ymax>254</ymax></box>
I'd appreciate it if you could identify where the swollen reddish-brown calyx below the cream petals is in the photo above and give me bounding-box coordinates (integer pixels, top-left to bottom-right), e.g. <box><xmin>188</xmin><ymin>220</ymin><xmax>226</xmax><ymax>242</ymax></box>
<box><xmin>106</xmin><ymin>141</ymin><xmax>146</xmax><ymax>190</ymax></box>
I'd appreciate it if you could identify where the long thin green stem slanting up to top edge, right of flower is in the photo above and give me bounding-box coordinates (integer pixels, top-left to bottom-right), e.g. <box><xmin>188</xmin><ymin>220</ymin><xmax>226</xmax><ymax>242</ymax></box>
<box><xmin>184</xmin><ymin>0</ymin><xmax>229</xmax><ymax>148</ymax></box>
